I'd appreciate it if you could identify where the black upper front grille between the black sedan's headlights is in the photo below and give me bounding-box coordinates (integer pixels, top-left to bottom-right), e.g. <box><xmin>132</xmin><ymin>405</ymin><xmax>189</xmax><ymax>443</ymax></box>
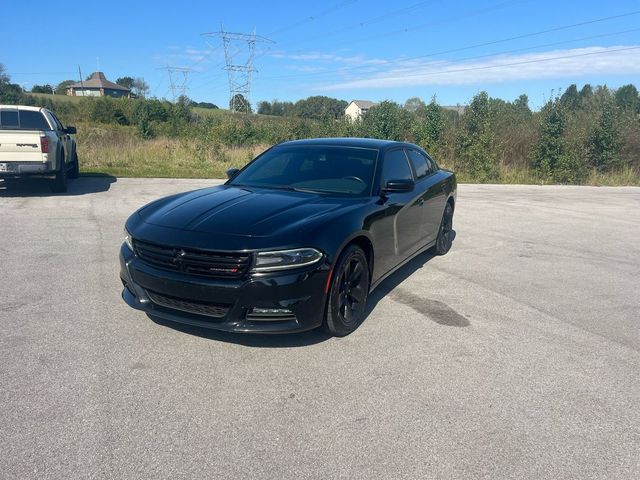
<box><xmin>133</xmin><ymin>240</ymin><xmax>251</xmax><ymax>278</ymax></box>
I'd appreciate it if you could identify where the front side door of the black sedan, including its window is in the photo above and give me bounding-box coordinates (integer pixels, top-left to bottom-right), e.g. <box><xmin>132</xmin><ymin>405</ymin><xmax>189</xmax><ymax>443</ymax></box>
<box><xmin>379</xmin><ymin>148</ymin><xmax>423</xmax><ymax>271</ymax></box>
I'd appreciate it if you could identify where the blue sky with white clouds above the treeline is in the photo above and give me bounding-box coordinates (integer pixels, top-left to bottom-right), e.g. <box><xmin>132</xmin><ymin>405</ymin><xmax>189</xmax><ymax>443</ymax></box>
<box><xmin>0</xmin><ymin>0</ymin><xmax>640</xmax><ymax>108</ymax></box>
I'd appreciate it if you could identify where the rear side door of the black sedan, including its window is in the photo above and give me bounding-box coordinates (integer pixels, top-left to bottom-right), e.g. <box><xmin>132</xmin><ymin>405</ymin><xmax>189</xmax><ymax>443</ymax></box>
<box><xmin>407</xmin><ymin>148</ymin><xmax>446</xmax><ymax>244</ymax></box>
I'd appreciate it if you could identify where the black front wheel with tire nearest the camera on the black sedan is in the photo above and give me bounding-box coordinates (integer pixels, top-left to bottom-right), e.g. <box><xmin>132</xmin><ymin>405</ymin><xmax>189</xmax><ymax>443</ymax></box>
<box><xmin>322</xmin><ymin>245</ymin><xmax>369</xmax><ymax>337</ymax></box>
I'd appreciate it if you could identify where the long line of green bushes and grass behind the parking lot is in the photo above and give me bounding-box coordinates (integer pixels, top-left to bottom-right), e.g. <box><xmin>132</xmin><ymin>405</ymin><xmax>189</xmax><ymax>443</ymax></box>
<box><xmin>0</xmin><ymin>85</ymin><xmax>640</xmax><ymax>185</ymax></box>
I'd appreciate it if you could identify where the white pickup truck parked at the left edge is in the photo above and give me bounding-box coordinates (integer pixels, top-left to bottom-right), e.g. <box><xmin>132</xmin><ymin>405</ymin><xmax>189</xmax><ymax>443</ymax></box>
<box><xmin>0</xmin><ymin>105</ymin><xmax>79</xmax><ymax>192</ymax></box>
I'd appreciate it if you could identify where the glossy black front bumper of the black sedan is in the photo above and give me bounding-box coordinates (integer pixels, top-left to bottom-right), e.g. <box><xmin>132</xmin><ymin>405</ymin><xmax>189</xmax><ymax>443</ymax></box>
<box><xmin>120</xmin><ymin>244</ymin><xmax>330</xmax><ymax>333</ymax></box>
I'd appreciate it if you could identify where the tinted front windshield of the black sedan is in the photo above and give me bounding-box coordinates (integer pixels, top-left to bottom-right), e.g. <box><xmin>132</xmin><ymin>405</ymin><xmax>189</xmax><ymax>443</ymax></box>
<box><xmin>229</xmin><ymin>145</ymin><xmax>378</xmax><ymax>196</ymax></box>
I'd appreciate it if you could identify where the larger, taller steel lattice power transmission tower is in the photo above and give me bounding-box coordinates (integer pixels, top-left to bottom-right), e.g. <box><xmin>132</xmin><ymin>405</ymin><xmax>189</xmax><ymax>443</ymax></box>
<box><xmin>203</xmin><ymin>26</ymin><xmax>273</xmax><ymax>113</ymax></box>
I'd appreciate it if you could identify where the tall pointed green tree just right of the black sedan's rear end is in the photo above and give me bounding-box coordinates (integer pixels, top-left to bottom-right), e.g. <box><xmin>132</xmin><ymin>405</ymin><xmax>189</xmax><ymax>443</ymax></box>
<box><xmin>458</xmin><ymin>92</ymin><xmax>500</xmax><ymax>182</ymax></box>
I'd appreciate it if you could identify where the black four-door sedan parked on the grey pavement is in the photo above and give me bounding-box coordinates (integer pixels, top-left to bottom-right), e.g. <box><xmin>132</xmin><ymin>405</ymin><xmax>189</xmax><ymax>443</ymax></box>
<box><xmin>120</xmin><ymin>138</ymin><xmax>457</xmax><ymax>336</ymax></box>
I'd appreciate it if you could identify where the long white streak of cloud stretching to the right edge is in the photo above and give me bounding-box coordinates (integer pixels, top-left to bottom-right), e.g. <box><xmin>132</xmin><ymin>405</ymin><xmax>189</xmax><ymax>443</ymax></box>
<box><xmin>316</xmin><ymin>45</ymin><xmax>640</xmax><ymax>91</ymax></box>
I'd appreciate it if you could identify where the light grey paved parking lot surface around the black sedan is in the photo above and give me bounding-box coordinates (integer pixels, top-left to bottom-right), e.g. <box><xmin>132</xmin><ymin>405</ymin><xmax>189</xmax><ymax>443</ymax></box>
<box><xmin>0</xmin><ymin>177</ymin><xmax>640</xmax><ymax>480</ymax></box>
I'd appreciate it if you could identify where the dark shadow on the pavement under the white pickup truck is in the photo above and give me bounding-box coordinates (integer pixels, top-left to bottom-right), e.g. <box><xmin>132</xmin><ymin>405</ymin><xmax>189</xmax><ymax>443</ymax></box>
<box><xmin>0</xmin><ymin>175</ymin><xmax>118</xmax><ymax>197</ymax></box>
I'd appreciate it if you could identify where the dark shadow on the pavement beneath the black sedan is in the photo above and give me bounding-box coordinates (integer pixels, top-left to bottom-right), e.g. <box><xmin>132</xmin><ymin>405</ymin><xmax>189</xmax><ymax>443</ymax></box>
<box><xmin>147</xmin><ymin>230</ymin><xmax>456</xmax><ymax>348</ymax></box>
